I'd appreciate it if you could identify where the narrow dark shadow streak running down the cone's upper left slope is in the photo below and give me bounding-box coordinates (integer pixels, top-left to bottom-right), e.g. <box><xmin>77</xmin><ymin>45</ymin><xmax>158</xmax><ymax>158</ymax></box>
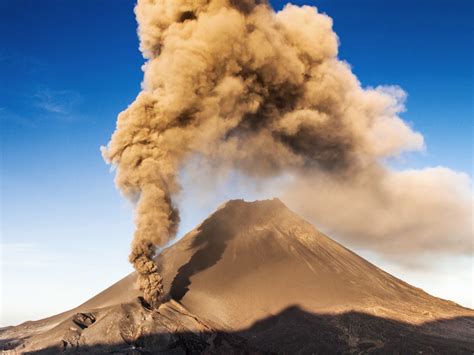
<box><xmin>170</xmin><ymin>201</ymin><xmax>246</xmax><ymax>301</ymax></box>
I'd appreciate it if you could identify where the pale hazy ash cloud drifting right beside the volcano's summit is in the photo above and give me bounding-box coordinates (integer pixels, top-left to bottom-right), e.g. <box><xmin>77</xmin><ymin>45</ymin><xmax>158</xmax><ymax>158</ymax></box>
<box><xmin>282</xmin><ymin>167</ymin><xmax>473</xmax><ymax>262</ymax></box>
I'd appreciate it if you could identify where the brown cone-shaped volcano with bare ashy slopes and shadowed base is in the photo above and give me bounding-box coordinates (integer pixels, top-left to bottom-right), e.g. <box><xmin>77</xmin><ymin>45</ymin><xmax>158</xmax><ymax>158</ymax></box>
<box><xmin>0</xmin><ymin>199</ymin><xmax>474</xmax><ymax>354</ymax></box>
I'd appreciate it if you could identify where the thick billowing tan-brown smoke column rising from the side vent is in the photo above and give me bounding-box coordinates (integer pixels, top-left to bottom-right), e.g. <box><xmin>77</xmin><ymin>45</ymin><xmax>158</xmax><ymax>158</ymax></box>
<box><xmin>103</xmin><ymin>0</ymin><xmax>430</xmax><ymax>306</ymax></box>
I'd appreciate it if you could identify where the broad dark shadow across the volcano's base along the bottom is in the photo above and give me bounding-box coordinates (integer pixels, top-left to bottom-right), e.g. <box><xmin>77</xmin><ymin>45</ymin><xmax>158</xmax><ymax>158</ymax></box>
<box><xmin>22</xmin><ymin>306</ymin><xmax>474</xmax><ymax>354</ymax></box>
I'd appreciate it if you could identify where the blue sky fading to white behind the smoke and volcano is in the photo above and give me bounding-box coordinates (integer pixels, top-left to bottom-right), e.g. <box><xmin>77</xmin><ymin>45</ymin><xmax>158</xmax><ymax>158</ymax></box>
<box><xmin>0</xmin><ymin>0</ymin><xmax>474</xmax><ymax>325</ymax></box>
